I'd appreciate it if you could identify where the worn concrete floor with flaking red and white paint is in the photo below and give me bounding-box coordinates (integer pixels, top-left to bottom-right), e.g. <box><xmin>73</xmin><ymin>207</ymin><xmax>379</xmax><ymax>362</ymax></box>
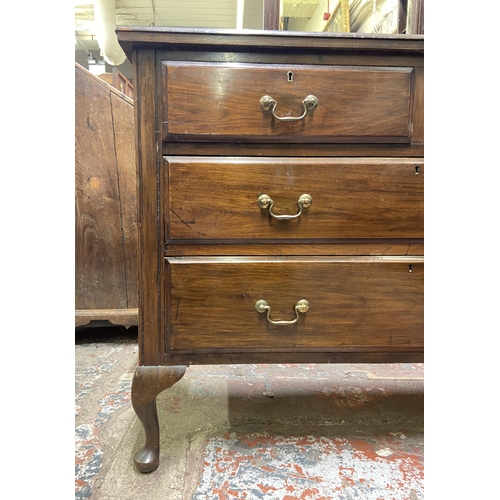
<box><xmin>75</xmin><ymin>327</ymin><xmax>424</xmax><ymax>500</ymax></box>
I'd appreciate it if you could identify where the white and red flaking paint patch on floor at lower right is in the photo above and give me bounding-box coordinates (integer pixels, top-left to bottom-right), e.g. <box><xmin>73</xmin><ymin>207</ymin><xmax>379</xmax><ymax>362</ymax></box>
<box><xmin>192</xmin><ymin>433</ymin><xmax>423</xmax><ymax>500</ymax></box>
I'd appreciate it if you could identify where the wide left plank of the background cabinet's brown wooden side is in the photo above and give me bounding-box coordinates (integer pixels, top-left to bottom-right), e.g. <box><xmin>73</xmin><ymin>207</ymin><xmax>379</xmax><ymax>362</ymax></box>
<box><xmin>75</xmin><ymin>63</ymin><xmax>130</xmax><ymax>312</ymax></box>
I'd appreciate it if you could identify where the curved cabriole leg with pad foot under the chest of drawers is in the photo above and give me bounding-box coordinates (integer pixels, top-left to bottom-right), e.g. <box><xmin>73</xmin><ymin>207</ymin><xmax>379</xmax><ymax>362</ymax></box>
<box><xmin>132</xmin><ymin>366</ymin><xmax>186</xmax><ymax>472</ymax></box>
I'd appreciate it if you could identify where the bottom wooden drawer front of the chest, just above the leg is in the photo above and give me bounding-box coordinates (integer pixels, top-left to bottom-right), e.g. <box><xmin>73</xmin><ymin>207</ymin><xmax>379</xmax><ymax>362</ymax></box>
<box><xmin>165</xmin><ymin>257</ymin><xmax>424</xmax><ymax>352</ymax></box>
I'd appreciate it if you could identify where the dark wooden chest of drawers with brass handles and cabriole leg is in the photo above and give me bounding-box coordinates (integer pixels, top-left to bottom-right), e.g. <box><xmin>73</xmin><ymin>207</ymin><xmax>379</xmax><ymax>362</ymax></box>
<box><xmin>118</xmin><ymin>28</ymin><xmax>424</xmax><ymax>472</ymax></box>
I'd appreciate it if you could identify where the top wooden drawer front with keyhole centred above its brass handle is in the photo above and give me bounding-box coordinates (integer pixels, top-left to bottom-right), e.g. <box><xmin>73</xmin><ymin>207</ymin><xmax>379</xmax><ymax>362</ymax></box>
<box><xmin>162</xmin><ymin>62</ymin><xmax>415</xmax><ymax>143</ymax></box>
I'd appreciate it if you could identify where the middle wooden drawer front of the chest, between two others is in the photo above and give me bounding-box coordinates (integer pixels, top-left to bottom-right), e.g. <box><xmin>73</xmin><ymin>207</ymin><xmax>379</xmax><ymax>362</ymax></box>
<box><xmin>164</xmin><ymin>157</ymin><xmax>424</xmax><ymax>240</ymax></box>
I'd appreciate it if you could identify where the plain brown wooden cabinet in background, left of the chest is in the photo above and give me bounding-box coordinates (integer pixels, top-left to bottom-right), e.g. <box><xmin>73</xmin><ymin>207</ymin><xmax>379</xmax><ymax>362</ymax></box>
<box><xmin>75</xmin><ymin>63</ymin><xmax>138</xmax><ymax>327</ymax></box>
